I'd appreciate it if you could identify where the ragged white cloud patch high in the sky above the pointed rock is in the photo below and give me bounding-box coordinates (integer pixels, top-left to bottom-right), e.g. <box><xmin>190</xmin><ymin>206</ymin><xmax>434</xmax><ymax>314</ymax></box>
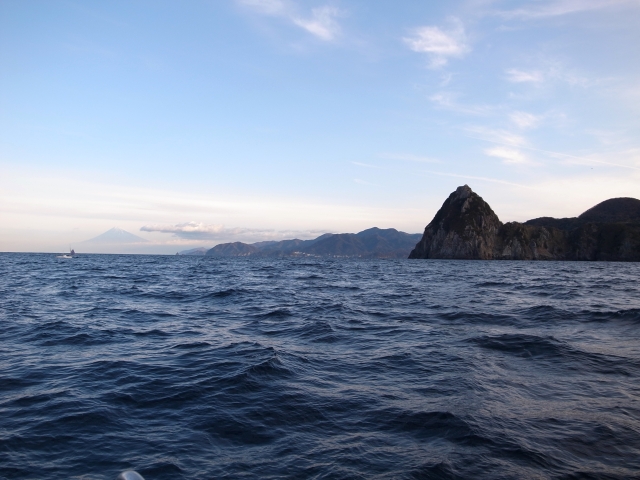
<box><xmin>403</xmin><ymin>19</ymin><xmax>469</xmax><ymax>68</ymax></box>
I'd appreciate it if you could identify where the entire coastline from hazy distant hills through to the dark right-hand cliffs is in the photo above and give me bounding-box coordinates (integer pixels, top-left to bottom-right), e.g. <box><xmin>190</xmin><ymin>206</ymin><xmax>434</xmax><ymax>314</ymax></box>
<box><xmin>191</xmin><ymin>185</ymin><xmax>640</xmax><ymax>262</ymax></box>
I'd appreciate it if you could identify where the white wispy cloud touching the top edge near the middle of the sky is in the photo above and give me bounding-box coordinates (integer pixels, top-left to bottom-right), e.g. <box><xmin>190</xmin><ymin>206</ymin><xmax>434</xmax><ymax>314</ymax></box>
<box><xmin>236</xmin><ymin>0</ymin><xmax>343</xmax><ymax>42</ymax></box>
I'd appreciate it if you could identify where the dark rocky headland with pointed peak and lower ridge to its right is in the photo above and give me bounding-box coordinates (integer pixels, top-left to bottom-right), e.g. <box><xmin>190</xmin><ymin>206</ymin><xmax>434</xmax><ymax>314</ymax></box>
<box><xmin>409</xmin><ymin>185</ymin><xmax>640</xmax><ymax>261</ymax></box>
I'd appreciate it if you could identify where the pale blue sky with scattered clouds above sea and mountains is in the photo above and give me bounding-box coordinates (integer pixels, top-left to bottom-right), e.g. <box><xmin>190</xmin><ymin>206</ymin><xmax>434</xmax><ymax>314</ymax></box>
<box><xmin>0</xmin><ymin>0</ymin><xmax>640</xmax><ymax>253</ymax></box>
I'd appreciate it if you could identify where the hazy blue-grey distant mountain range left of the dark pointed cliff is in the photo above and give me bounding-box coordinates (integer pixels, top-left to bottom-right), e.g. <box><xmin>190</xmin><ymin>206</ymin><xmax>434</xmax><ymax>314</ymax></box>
<box><xmin>200</xmin><ymin>227</ymin><xmax>422</xmax><ymax>258</ymax></box>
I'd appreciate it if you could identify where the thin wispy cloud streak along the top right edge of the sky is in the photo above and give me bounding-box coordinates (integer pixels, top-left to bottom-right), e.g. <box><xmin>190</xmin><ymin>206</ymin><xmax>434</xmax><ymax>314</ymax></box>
<box><xmin>497</xmin><ymin>0</ymin><xmax>640</xmax><ymax>20</ymax></box>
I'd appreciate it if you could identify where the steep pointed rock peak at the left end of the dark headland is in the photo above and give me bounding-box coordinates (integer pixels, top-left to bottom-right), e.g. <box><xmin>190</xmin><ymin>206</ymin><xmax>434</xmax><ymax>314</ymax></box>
<box><xmin>409</xmin><ymin>185</ymin><xmax>502</xmax><ymax>260</ymax></box>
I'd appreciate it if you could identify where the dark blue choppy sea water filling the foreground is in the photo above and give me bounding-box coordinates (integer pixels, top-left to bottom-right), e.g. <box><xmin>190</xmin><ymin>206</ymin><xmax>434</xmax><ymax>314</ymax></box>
<box><xmin>0</xmin><ymin>254</ymin><xmax>640</xmax><ymax>480</ymax></box>
